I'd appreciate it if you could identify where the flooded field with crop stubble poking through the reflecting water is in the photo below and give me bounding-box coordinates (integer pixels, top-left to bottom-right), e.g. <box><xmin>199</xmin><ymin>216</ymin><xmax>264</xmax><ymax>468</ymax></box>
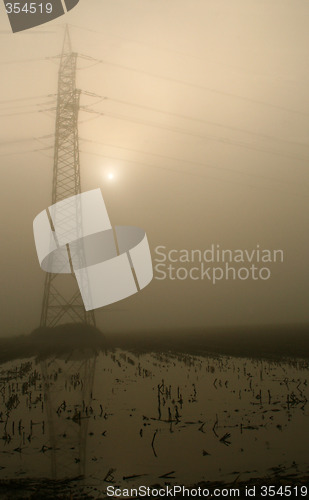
<box><xmin>0</xmin><ymin>349</ymin><xmax>309</xmax><ymax>496</ymax></box>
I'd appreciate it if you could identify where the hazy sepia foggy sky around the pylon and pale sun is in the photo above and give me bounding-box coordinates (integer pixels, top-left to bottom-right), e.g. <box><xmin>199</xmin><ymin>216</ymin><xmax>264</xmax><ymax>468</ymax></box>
<box><xmin>0</xmin><ymin>0</ymin><xmax>309</xmax><ymax>336</ymax></box>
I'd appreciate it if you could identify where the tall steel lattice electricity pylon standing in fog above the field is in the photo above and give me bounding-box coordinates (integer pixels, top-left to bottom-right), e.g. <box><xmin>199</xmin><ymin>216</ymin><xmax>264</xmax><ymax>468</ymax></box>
<box><xmin>40</xmin><ymin>27</ymin><xmax>95</xmax><ymax>327</ymax></box>
